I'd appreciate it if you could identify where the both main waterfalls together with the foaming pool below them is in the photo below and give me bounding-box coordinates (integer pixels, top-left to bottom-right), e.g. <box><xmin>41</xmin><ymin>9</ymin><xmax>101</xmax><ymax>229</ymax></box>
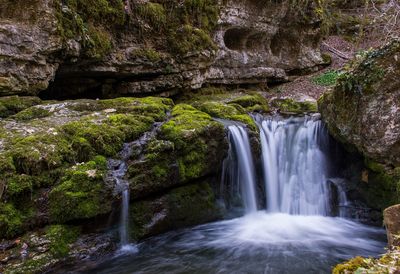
<box><xmin>86</xmin><ymin>117</ymin><xmax>386</xmax><ymax>274</ymax></box>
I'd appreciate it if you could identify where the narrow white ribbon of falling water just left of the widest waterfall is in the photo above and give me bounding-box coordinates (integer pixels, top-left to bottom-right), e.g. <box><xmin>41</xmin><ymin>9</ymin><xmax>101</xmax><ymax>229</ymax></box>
<box><xmin>228</xmin><ymin>125</ymin><xmax>257</xmax><ymax>213</ymax></box>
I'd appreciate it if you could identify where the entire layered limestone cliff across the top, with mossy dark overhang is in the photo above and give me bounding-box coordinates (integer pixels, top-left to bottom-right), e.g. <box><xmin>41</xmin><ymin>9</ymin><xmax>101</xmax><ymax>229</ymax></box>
<box><xmin>0</xmin><ymin>0</ymin><xmax>322</xmax><ymax>99</ymax></box>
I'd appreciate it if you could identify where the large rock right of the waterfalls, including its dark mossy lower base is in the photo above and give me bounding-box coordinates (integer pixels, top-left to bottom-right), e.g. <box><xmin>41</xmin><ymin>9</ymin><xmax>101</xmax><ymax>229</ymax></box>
<box><xmin>319</xmin><ymin>40</ymin><xmax>400</xmax><ymax>210</ymax></box>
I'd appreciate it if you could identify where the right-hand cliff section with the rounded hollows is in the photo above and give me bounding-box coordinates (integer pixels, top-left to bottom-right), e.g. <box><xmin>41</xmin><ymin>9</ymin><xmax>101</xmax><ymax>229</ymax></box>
<box><xmin>206</xmin><ymin>0</ymin><xmax>321</xmax><ymax>84</ymax></box>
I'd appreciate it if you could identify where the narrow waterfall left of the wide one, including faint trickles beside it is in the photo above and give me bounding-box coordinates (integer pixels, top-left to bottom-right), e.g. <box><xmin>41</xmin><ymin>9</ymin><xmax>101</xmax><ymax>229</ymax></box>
<box><xmin>222</xmin><ymin>125</ymin><xmax>257</xmax><ymax>213</ymax></box>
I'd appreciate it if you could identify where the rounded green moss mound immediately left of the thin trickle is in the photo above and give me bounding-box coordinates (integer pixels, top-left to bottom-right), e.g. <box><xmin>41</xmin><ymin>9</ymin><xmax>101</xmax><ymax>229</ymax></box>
<box><xmin>49</xmin><ymin>156</ymin><xmax>111</xmax><ymax>223</ymax></box>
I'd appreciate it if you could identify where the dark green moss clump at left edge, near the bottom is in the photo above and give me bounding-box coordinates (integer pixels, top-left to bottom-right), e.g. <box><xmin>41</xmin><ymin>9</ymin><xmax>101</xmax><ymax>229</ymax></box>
<box><xmin>0</xmin><ymin>202</ymin><xmax>23</xmax><ymax>238</ymax></box>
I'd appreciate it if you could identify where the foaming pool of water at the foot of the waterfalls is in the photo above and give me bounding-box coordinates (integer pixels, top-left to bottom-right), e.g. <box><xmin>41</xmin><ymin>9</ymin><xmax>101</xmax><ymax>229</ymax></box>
<box><xmin>89</xmin><ymin>211</ymin><xmax>385</xmax><ymax>274</ymax></box>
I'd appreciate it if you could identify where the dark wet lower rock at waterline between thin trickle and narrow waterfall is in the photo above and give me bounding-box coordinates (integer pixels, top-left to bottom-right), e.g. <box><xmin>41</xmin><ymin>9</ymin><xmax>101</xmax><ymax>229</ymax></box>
<box><xmin>130</xmin><ymin>181</ymin><xmax>221</xmax><ymax>239</ymax></box>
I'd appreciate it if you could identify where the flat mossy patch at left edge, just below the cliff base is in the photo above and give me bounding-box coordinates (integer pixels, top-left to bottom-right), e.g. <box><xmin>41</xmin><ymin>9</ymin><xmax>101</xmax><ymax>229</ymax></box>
<box><xmin>0</xmin><ymin>96</ymin><xmax>41</xmax><ymax>118</ymax></box>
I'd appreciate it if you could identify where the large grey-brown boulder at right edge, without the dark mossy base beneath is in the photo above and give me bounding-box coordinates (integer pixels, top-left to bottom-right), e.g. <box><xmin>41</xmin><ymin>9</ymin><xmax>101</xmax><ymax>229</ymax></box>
<box><xmin>319</xmin><ymin>40</ymin><xmax>400</xmax><ymax>166</ymax></box>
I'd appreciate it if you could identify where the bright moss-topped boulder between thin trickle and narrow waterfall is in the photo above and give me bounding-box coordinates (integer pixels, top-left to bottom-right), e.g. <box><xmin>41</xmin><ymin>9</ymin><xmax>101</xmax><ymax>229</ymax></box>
<box><xmin>128</xmin><ymin>104</ymin><xmax>227</xmax><ymax>198</ymax></box>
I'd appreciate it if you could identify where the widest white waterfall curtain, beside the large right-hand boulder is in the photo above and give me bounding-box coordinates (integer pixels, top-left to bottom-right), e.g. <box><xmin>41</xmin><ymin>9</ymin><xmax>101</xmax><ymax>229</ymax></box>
<box><xmin>258</xmin><ymin>117</ymin><xmax>330</xmax><ymax>216</ymax></box>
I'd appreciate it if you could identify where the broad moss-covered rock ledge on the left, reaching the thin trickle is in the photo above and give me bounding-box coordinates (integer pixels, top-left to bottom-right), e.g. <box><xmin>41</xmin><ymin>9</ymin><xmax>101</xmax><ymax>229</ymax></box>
<box><xmin>0</xmin><ymin>97</ymin><xmax>173</xmax><ymax>237</ymax></box>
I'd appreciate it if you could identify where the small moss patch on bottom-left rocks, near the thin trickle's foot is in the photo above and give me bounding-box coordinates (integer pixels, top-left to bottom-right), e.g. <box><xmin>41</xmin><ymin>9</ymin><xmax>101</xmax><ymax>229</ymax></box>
<box><xmin>46</xmin><ymin>225</ymin><xmax>79</xmax><ymax>258</ymax></box>
